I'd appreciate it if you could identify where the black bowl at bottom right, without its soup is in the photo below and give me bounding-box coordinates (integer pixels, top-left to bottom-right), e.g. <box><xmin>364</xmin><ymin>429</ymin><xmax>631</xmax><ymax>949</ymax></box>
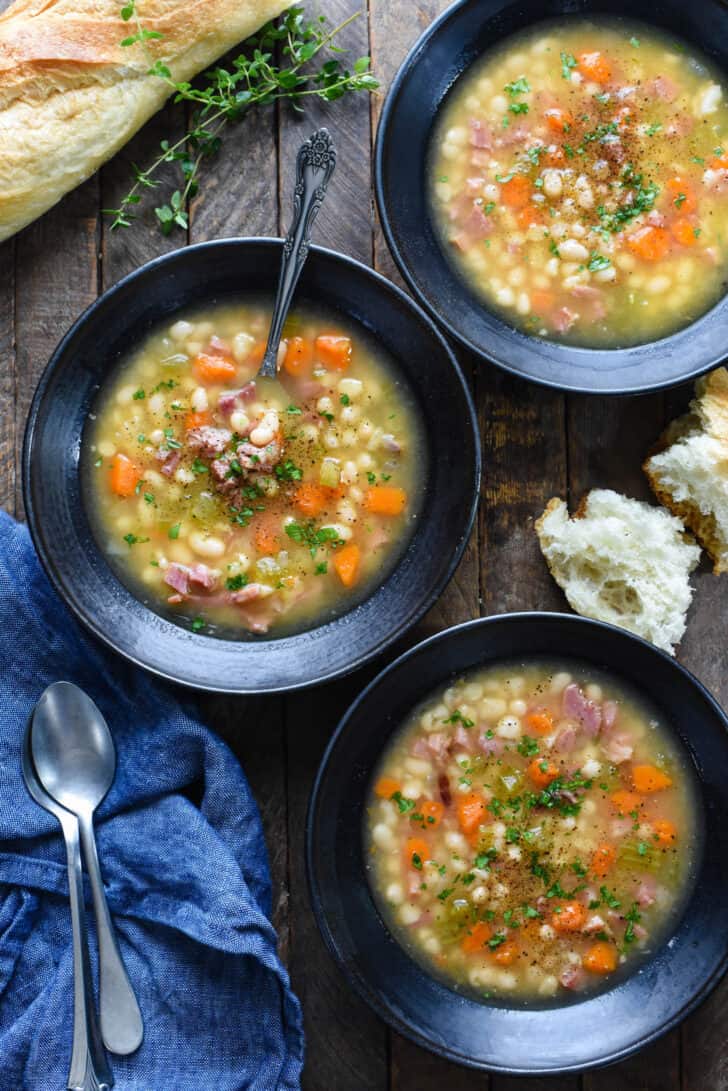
<box><xmin>306</xmin><ymin>613</ymin><xmax>728</xmax><ymax>1076</ymax></box>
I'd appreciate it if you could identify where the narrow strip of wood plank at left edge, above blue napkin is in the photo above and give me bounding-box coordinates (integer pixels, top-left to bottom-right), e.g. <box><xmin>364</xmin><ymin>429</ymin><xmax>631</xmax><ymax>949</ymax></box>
<box><xmin>0</xmin><ymin>239</ymin><xmax>16</xmax><ymax>512</ymax></box>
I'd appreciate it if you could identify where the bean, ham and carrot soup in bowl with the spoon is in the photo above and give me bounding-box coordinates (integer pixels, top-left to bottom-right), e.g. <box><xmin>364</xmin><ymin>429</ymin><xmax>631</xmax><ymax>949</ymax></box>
<box><xmin>84</xmin><ymin>303</ymin><xmax>423</xmax><ymax>637</ymax></box>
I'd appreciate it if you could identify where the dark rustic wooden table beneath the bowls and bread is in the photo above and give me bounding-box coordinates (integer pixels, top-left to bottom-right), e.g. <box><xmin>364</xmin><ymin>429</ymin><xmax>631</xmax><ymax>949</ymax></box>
<box><xmin>0</xmin><ymin>0</ymin><xmax>728</xmax><ymax>1091</ymax></box>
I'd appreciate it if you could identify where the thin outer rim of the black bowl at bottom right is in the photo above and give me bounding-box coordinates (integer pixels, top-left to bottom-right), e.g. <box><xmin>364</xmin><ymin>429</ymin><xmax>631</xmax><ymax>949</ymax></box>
<box><xmin>303</xmin><ymin>610</ymin><xmax>728</xmax><ymax>1077</ymax></box>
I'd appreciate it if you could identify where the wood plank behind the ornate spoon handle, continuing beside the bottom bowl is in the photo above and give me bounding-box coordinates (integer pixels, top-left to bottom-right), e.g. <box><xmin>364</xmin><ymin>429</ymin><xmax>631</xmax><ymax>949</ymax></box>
<box><xmin>279</xmin><ymin>0</ymin><xmax>386</xmax><ymax>1091</ymax></box>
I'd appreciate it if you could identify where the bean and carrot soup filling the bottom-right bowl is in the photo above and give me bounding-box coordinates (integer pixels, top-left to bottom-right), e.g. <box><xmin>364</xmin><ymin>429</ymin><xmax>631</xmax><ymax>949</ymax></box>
<box><xmin>365</xmin><ymin>661</ymin><xmax>695</xmax><ymax>1002</ymax></box>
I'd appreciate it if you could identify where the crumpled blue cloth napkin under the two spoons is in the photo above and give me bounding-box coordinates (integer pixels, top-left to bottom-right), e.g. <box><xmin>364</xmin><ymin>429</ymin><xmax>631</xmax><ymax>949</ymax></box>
<box><xmin>0</xmin><ymin>513</ymin><xmax>303</xmax><ymax>1091</ymax></box>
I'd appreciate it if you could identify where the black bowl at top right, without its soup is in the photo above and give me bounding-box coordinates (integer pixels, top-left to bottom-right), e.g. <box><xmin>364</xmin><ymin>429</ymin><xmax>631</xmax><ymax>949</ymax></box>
<box><xmin>374</xmin><ymin>0</ymin><xmax>728</xmax><ymax>394</ymax></box>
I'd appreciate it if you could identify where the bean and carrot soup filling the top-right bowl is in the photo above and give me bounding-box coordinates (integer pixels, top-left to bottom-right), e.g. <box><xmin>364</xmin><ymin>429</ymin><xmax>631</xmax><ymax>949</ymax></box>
<box><xmin>430</xmin><ymin>20</ymin><xmax>728</xmax><ymax>348</ymax></box>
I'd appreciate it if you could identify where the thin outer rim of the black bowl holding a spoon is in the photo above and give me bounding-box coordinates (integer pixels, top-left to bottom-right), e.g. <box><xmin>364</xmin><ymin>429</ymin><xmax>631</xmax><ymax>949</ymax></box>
<box><xmin>21</xmin><ymin>236</ymin><xmax>482</xmax><ymax>696</ymax></box>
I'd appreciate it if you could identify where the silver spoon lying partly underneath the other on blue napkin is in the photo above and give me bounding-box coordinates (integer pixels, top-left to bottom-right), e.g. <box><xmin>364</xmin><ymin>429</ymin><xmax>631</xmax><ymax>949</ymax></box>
<box><xmin>21</xmin><ymin>702</ymin><xmax>114</xmax><ymax>1091</ymax></box>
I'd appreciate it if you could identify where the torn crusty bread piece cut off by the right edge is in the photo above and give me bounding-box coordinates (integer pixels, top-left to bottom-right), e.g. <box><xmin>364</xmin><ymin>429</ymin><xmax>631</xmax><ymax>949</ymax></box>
<box><xmin>644</xmin><ymin>368</ymin><xmax>728</xmax><ymax>573</ymax></box>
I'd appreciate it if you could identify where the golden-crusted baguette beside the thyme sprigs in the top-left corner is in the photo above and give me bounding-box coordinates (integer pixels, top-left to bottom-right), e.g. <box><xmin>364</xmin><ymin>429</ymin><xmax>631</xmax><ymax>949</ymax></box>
<box><xmin>0</xmin><ymin>0</ymin><xmax>290</xmax><ymax>241</ymax></box>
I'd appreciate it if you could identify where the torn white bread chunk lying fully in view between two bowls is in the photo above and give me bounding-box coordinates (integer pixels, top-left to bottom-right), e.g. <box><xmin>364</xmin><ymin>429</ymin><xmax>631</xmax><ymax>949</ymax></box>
<box><xmin>536</xmin><ymin>489</ymin><xmax>701</xmax><ymax>655</ymax></box>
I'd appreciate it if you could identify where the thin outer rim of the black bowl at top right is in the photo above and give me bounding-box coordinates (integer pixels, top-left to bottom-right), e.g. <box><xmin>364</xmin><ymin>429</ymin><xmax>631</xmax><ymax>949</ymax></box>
<box><xmin>372</xmin><ymin>0</ymin><xmax>728</xmax><ymax>397</ymax></box>
